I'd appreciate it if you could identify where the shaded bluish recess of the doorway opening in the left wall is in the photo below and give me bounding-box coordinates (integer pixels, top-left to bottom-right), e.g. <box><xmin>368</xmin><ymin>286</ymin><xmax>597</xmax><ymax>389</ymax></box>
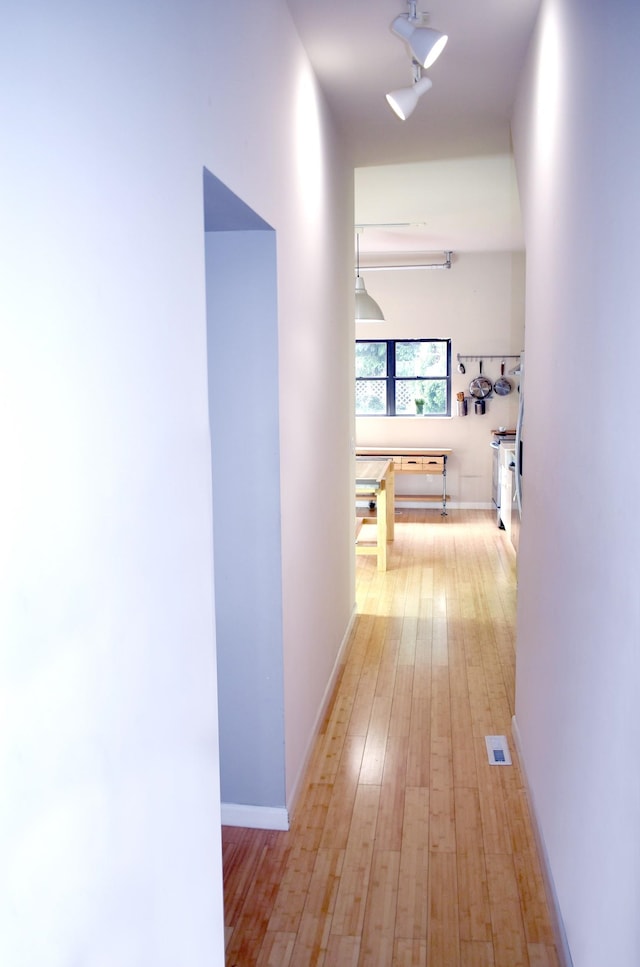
<box><xmin>203</xmin><ymin>169</ymin><xmax>288</xmax><ymax>828</ymax></box>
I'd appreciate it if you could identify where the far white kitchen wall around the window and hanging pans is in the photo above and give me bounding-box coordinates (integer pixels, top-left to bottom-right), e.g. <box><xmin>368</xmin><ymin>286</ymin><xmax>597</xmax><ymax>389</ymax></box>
<box><xmin>356</xmin><ymin>252</ymin><xmax>524</xmax><ymax>507</ymax></box>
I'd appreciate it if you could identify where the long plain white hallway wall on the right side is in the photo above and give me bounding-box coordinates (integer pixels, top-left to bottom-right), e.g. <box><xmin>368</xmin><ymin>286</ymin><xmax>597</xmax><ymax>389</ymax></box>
<box><xmin>514</xmin><ymin>0</ymin><xmax>640</xmax><ymax>967</ymax></box>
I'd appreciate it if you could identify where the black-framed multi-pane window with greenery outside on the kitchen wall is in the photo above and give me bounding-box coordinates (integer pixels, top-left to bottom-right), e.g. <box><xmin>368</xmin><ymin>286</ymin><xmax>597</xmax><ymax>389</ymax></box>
<box><xmin>356</xmin><ymin>339</ymin><xmax>451</xmax><ymax>416</ymax></box>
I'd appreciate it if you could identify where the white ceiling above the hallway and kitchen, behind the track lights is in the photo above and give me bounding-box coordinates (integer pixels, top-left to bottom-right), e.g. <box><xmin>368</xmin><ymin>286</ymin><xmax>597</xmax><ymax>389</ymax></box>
<box><xmin>287</xmin><ymin>0</ymin><xmax>540</xmax><ymax>258</ymax></box>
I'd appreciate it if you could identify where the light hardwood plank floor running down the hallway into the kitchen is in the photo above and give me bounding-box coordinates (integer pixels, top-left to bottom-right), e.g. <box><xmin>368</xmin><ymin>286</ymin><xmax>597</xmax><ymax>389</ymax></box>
<box><xmin>223</xmin><ymin>508</ymin><xmax>558</xmax><ymax>967</ymax></box>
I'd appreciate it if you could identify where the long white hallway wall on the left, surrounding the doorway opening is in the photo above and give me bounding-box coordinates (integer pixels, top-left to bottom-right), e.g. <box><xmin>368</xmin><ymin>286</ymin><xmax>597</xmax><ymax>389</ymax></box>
<box><xmin>0</xmin><ymin>0</ymin><xmax>353</xmax><ymax>967</ymax></box>
